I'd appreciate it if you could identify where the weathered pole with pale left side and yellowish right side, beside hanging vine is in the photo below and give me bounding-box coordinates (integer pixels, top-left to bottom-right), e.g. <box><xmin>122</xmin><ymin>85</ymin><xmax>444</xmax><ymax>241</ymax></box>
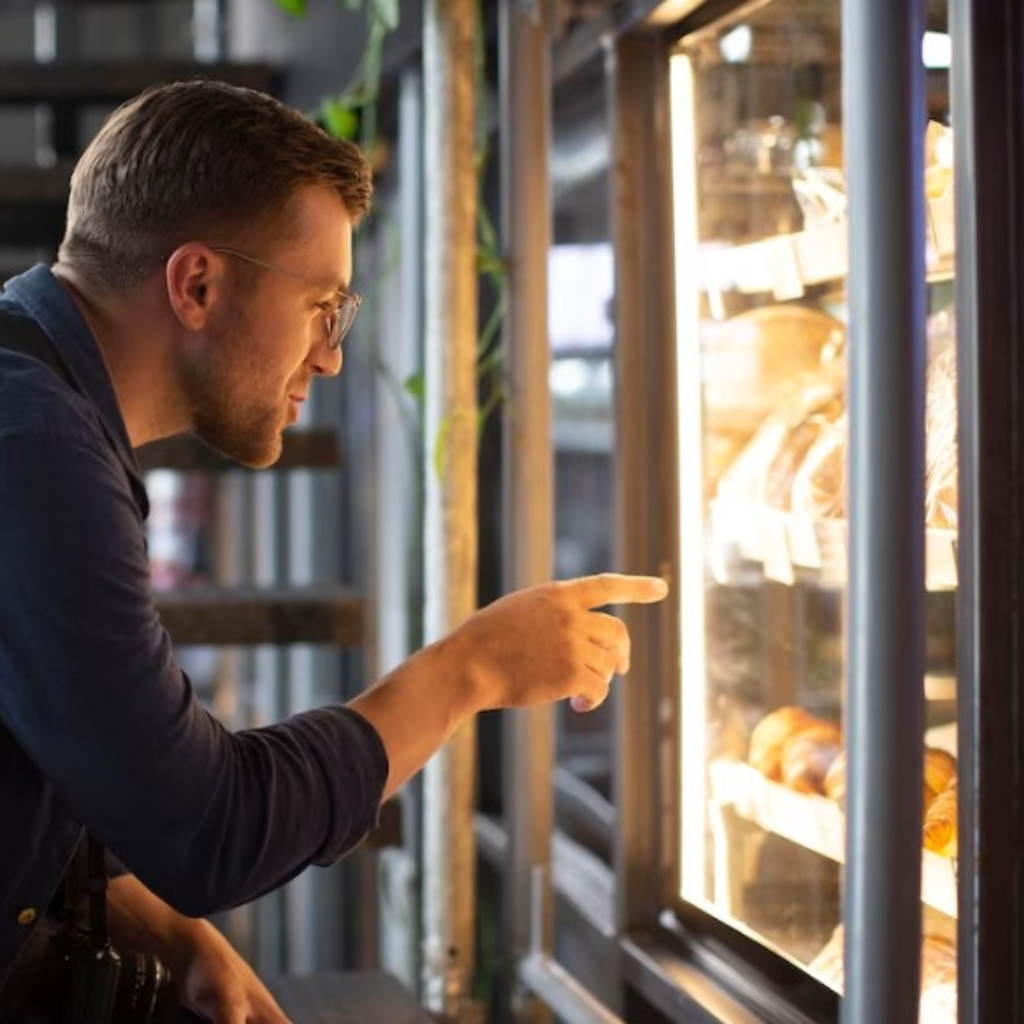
<box><xmin>423</xmin><ymin>6</ymin><xmax>477</xmax><ymax>1020</ymax></box>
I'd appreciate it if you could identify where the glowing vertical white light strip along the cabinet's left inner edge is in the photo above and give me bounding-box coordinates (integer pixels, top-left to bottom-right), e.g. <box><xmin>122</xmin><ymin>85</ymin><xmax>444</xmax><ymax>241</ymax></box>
<box><xmin>670</xmin><ymin>54</ymin><xmax>708</xmax><ymax>901</ymax></box>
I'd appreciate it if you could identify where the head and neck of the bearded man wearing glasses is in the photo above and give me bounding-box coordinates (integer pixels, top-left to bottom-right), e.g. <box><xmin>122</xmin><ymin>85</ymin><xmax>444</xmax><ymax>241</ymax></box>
<box><xmin>54</xmin><ymin>81</ymin><xmax>372</xmax><ymax>466</ymax></box>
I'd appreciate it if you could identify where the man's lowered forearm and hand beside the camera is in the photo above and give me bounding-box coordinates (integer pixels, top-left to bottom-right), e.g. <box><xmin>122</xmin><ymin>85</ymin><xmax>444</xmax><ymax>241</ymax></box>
<box><xmin>106</xmin><ymin>874</ymin><xmax>289</xmax><ymax>1024</ymax></box>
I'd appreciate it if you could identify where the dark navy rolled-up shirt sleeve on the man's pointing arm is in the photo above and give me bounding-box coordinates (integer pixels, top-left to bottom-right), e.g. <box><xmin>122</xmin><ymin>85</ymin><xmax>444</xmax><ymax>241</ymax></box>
<box><xmin>0</xmin><ymin>424</ymin><xmax>388</xmax><ymax>915</ymax></box>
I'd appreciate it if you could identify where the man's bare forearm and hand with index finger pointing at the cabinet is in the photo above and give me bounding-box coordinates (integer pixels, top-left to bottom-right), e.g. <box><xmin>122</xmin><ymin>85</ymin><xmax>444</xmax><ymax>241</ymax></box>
<box><xmin>349</xmin><ymin>573</ymin><xmax>668</xmax><ymax>797</ymax></box>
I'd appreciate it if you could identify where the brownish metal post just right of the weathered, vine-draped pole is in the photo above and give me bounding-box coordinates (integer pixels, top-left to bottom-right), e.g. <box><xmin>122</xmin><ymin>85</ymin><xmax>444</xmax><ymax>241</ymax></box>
<box><xmin>500</xmin><ymin>0</ymin><xmax>554</xmax><ymax>1021</ymax></box>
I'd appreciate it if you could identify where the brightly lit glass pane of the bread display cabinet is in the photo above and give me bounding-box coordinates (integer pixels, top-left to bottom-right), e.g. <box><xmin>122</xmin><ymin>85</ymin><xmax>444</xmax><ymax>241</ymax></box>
<box><xmin>671</xmin><ymin>0</ymin><xmax>956</xmax><ymax>1022</ymax></box>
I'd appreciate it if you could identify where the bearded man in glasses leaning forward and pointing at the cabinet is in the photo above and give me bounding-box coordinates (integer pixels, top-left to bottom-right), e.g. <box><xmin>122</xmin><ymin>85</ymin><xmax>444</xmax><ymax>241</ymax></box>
<box><xmin>0</xmin><ymin>82</ymin><xmax>665</xmax><ymax>1024</ymax></box>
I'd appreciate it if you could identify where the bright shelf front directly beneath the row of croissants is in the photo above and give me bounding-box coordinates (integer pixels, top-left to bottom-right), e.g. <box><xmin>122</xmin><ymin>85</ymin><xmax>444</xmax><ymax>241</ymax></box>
<box><xmin>709</xmin><ymin>761</ymin><xmax>956</xmax><ymax>918</ymax></box>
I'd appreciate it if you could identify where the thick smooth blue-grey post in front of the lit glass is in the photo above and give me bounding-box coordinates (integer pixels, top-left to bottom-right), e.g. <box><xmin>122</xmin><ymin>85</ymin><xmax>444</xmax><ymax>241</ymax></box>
<box><xmin>843</xmin><ymin>0</ymin><xmax>926</xmax><ymax>1024</ymax></box>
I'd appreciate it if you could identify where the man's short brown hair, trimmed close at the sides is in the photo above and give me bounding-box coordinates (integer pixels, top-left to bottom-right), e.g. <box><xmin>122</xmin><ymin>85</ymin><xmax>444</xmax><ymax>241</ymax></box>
<box><xmin>60</xmin><ymin>80</ymin><xmax>373</xmax><ymax>288</ymax></box>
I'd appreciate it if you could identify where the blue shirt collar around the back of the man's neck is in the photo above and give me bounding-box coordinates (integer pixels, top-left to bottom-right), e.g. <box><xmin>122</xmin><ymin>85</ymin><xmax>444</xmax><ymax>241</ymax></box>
<box><xmin>0</xmin><ymin>263</ymin><xmax>148</xmax><ymax>517</ymax></box>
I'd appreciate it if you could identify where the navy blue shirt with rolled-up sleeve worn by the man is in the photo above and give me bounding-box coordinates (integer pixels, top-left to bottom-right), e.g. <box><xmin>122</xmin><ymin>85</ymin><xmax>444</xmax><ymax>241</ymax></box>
<box><xmin>0</xmin><ymin>266</ymin><xmax>387</xmax><ymax>987</ymax></box>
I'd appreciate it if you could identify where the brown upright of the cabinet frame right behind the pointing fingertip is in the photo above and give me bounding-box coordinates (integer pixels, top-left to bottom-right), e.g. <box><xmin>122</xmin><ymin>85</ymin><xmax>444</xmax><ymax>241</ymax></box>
<box><xmin>608</xmin><ymin>33</ymin><xmax>679</xmax><ymax>932</ymax></box>
